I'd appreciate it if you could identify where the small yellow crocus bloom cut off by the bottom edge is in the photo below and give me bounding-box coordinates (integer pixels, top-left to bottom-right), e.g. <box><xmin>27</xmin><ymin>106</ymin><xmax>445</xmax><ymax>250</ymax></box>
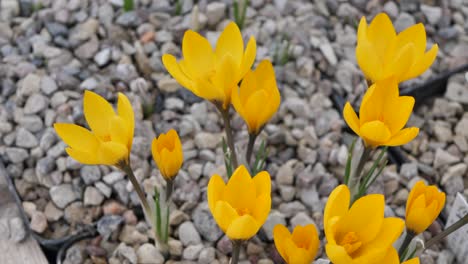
<box><xmin>273</xmin><ymin>224</ymin><xmax>320</xmax><ymax>264</ymax></box>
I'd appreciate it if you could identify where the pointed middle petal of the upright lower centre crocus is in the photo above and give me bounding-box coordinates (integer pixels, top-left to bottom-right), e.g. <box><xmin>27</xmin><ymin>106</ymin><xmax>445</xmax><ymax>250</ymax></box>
<box><xmin>223</xmin><ymin>165</ymin><xmax>257</xmax><ymax>212</ymax></box>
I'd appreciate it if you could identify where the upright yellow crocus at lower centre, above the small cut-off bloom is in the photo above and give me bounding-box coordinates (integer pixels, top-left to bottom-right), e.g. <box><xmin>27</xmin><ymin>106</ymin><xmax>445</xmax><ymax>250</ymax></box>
<box><xmin>207</xmin><ymin>165</ymin><xmax>271</xmax><ymax>241</ymax></box>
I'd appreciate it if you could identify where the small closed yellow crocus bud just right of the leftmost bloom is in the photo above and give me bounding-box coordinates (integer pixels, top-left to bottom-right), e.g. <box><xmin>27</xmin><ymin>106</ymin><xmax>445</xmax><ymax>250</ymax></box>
<box><xmin>151</xmin><ymin>129</ymin><xmax>184</xmax><ymax>180</ymax></box>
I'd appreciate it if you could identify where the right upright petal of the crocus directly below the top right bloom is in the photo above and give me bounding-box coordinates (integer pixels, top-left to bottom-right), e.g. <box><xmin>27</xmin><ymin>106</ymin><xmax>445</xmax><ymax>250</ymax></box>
<box><xmin>384</xmin><ymin>96</ymin><xmax>414</xmax><ymax>135</ymax></box>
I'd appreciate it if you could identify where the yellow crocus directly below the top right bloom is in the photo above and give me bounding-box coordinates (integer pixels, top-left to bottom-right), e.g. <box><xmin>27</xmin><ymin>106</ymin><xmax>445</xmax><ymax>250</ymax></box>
<box><xmin>343</xmin><ymin>78</ymin><xmax>419</xmax><ymax>147</ymax></box>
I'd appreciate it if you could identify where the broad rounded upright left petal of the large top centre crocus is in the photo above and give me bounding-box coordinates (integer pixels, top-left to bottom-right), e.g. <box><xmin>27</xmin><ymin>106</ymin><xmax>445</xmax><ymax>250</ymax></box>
<box><xmin>182</xmin><ymin>30</ymin><xmax>215</xmax><ymax>79</ymax></box>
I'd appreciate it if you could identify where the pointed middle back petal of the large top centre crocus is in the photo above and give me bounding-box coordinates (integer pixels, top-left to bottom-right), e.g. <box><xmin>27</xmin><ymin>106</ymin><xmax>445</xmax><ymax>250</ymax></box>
<box><xmin>215</xmin><ymin>22</ymin><xmax>244</xmax><ymax>68</ymax></box>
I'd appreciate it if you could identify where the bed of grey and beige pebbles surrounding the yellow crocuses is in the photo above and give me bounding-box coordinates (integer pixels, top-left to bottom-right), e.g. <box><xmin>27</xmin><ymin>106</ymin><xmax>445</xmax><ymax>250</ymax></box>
<box><xmin>0</xmin><ymin>0</ymin><xmax>468</xmax><ymax>264</ymax></box>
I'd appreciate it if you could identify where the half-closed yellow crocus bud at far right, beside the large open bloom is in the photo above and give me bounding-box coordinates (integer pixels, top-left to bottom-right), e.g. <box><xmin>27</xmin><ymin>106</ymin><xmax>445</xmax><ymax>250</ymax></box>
<box><xmin>406</xmin><ymin>181</ymin><xmax>445</xmax><ymax>235</ymax></box>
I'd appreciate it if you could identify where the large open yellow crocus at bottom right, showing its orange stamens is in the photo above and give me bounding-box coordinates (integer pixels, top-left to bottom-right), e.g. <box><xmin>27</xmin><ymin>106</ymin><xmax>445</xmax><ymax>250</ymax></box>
<box><xmin>323</xmin><ymin>185</ymin><xmax>404</xmax><ymax>264</ymax></box>
